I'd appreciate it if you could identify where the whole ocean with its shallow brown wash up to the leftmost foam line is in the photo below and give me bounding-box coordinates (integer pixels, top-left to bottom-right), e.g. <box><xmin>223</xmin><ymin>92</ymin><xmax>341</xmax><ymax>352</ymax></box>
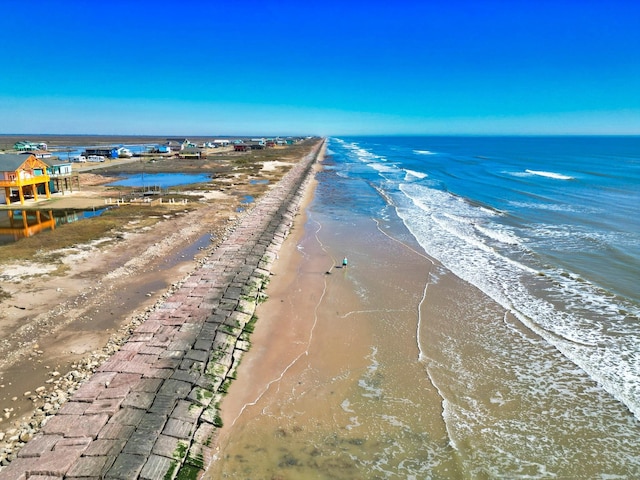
<box><xmin>211</xmin><ymin>136</ymin><xmax>640</xmax><ymax>479</ymax></box>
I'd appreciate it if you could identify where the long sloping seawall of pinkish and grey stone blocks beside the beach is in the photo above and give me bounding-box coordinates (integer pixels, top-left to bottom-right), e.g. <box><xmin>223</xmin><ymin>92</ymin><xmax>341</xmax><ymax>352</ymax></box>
<box><xmin>0</xmin><ymin>142</ymin><xmax>324</xmax><ymax>480</ymax></box>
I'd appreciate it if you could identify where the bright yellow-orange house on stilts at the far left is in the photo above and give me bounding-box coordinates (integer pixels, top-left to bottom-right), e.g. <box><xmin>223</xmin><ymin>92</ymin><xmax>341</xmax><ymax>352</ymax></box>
<box><xmin>0</xmin><ymin>153</ymin><xmax>51</xmax><ymax>205</ymax></box>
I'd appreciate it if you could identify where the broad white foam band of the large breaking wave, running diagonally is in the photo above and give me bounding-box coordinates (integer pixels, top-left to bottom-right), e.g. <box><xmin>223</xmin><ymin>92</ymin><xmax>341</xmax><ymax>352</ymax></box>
<box><xmin>398</xmin><ymin>183</ymin><xmax>640</xmax><ymax>418</ymax></box>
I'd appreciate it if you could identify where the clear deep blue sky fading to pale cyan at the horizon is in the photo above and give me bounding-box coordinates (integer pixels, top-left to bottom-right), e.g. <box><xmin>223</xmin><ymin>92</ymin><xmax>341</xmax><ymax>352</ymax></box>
<box><xmin>0</xmin><ymin>0</ymin><xmax>640</xmax><ymax>135</ymax></box>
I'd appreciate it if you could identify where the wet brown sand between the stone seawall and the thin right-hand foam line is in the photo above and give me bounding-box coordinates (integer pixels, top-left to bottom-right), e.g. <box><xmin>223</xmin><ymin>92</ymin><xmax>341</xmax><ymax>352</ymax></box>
<box><xmin>205</xmin><ymin>172</ymin><xmax>456</xmax><ymax>479</ymax></box>
